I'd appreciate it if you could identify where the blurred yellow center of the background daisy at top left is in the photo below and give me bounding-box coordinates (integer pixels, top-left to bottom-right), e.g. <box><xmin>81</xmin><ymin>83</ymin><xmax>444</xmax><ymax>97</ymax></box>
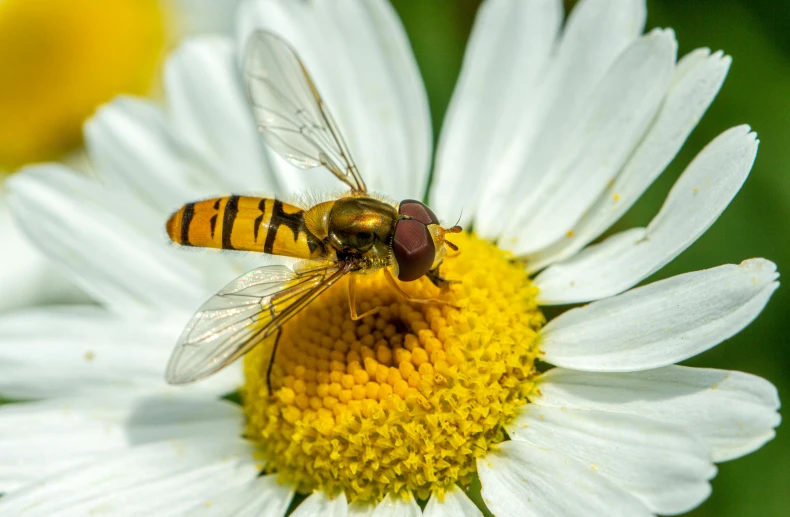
<box><xmin>0</xmin><ymin>0</ymin><xmax>165</xmax><ymax>169</ymax></box>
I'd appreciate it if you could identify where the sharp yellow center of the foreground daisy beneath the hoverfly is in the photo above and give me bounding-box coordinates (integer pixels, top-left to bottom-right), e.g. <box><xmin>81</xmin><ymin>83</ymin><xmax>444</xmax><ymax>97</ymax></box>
<box><xmin>242</xmin><ymin>234</ymin><xmax>545</xmax><ymax>500</ymax></box>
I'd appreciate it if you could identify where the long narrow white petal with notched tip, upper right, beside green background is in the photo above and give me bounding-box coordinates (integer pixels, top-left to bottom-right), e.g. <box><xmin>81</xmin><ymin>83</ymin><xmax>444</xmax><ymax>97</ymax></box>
<box><xmin>526</xmin><ymin>49</ymin><xmax>732</xmax><ymax>272</ymax></box>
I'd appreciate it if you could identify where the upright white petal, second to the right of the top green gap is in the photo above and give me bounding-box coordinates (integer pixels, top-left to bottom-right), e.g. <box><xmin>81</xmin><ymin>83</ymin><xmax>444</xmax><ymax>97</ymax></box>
<box><xmin>475</xmin><ymin>0</ymin><xmax>646</xmax><ymax>237</ymax></box>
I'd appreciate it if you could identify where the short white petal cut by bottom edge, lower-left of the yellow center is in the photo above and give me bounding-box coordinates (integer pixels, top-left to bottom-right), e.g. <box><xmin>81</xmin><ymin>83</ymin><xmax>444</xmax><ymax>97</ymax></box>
<box><xmin>190</xmin><ymin>474</ymin><xmax>294</xmax><ymax>517</ymax></box>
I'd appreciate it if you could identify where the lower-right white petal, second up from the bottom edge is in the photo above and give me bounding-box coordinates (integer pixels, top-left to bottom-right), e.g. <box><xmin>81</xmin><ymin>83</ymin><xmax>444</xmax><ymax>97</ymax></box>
<box><xmin>507</xmin><ymin>404</ymin><xmax>716</xmax><ymax>515</ymax></box>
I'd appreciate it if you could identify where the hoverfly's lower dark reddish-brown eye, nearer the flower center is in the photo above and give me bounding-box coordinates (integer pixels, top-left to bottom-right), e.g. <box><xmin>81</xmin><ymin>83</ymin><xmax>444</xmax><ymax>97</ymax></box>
<box><xmin>392</xmin><ymin>219</ymin><xmax>436</xmax><ymax>282</ymax></box>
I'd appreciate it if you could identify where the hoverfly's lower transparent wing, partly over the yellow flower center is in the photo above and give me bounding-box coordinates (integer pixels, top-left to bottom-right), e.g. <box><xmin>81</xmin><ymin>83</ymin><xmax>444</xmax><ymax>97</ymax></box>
<box><xmin>165</xmin><ymin>265</ymin><xmax>348</xmax><ymax>384</ymax></box>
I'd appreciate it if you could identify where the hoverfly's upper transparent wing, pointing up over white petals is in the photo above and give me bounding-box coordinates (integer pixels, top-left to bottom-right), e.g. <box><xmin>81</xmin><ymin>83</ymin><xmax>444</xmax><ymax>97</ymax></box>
<box><xmin>244</xmin><ymin>31</ymin><xmax>366</xmax><ymax>192</ymax></box>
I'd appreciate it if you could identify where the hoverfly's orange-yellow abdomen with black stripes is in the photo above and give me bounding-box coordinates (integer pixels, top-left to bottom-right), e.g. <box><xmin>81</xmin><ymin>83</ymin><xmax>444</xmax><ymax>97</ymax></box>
<box><xmin>167</xmin><ymin>196</ymin><xmax>327</xmax><ymax>259</ymax></box>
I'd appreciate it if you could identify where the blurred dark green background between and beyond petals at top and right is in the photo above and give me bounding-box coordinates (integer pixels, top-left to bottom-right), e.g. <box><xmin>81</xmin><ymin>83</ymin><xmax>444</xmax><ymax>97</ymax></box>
<box><xmin>393</xmin><ymin>0</ymin><xmax>790</xmax><ymax>517</ymax></box>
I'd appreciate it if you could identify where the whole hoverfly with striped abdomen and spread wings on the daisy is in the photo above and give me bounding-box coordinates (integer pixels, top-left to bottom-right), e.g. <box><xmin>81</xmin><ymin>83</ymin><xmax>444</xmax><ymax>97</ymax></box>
<box><xmin>165</xmin><ymin>32</ymin><xmax>461</xmax><ymax>393</ymax></box>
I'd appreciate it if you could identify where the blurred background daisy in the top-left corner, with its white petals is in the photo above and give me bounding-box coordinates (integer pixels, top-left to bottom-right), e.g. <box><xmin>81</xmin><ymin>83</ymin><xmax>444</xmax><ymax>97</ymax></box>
<box><xmin>0</xmin><ymin>0</ymin><xmax>243</xmax><ymax>310</ymax></box>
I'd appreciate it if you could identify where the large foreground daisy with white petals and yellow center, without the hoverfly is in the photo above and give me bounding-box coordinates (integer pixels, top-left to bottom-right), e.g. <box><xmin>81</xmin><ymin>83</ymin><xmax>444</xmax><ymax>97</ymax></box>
<box><xmin>0</xmin><ymin>0</ymin><xmax>779</xmax><ymax>517</ymax></box>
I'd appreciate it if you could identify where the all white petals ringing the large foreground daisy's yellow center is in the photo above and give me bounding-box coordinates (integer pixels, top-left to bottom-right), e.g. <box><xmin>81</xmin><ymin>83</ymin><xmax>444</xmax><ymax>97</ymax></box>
<box><xmin>0</xmin><ymin>0</ymin><xmax>778</xmax><ymax>515</ymax></box>
